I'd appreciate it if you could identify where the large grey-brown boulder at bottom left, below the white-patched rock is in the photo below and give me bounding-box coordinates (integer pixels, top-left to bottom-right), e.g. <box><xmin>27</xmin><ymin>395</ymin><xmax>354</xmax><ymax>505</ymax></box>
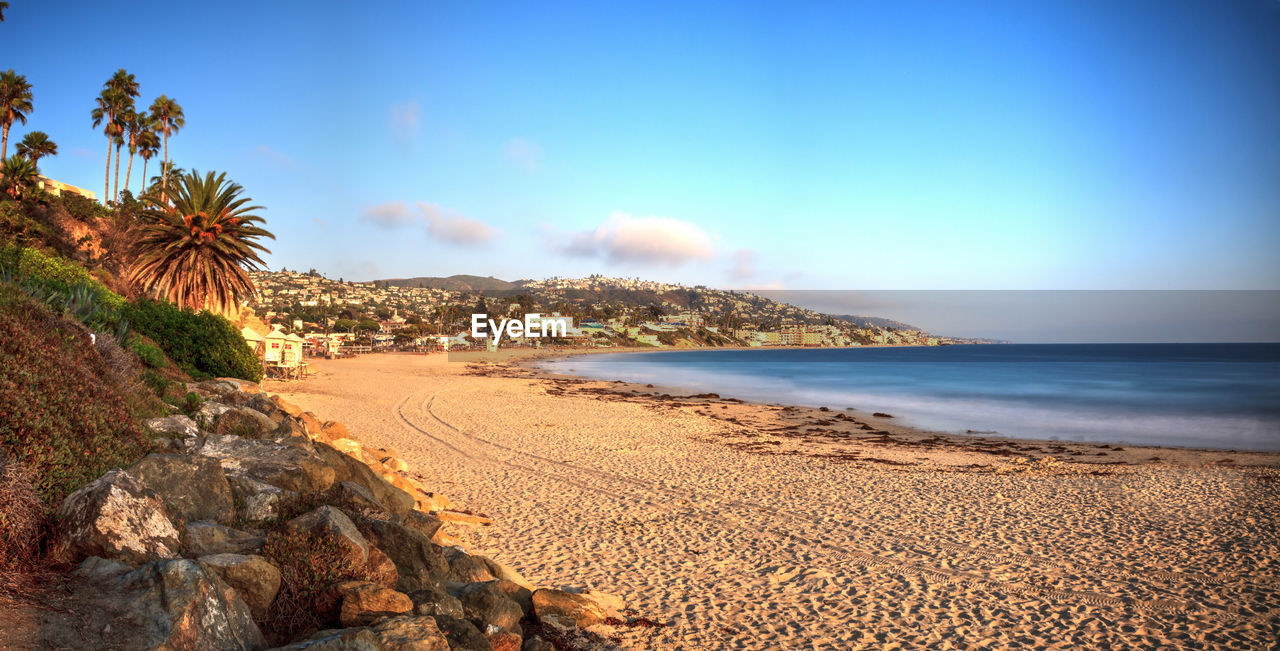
<box><xmin>86</xmin><ymin>559</ymin><xmax>266</xmax><ymax>651</ymax></box>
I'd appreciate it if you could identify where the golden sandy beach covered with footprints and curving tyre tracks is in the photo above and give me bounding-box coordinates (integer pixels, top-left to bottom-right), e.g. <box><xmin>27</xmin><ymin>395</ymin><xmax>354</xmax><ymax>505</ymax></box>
<box><xmin>272</xmin><ymin>354</ymin><xmax>1280</xmax><ymax>648</ymax></box>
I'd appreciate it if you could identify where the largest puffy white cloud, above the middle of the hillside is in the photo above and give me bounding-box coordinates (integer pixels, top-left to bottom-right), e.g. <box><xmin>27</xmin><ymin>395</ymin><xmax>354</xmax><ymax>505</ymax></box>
<box><xmin>557</xmin><ymin>211</ymin><xmax>716</xmax><ymax>266</ymax></box>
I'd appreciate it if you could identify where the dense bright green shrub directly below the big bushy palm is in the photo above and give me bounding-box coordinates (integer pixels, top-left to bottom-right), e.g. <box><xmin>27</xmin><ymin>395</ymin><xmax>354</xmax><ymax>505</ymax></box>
<box><xmin>123</xmin><ymin>298</ymin><xmax>262</xmax><ymax>382</ymax></box>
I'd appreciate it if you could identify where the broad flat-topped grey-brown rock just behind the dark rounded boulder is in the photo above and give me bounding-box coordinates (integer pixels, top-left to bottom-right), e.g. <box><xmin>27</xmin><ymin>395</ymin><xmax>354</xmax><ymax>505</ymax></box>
<box><xmin>198</xmin><ymin>435</ymin><xmax>334</xmax><ymax>494</ymax></box>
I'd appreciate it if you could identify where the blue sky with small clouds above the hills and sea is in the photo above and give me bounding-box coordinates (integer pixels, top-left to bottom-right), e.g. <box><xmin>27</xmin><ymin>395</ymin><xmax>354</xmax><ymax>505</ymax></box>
<box><xmin>0</xmin><ymin>0</ymin><xmax>1280</xmax><ymax>289</ymax></box>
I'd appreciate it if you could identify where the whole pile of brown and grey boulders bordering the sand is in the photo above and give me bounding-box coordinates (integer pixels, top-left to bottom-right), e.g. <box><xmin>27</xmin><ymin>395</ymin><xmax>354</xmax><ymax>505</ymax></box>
<box><xmin>20</xmin><ymin>379</ymin><xmax>627</xmax><ymax>651</ymax></box>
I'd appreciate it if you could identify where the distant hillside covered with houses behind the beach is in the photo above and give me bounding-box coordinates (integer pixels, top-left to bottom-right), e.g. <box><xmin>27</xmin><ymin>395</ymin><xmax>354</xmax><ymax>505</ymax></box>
<box><xmin>247</xmin><ymin>270</ymin><xmax>993</xmax><ymax>352</ymax></box>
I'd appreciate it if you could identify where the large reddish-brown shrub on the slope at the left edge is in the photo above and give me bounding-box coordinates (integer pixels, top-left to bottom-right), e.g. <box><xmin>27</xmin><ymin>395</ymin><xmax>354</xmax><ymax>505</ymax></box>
<box><xmin>0</xmin><ymin>284</ymin><xmax>150</xmax><ymax>504</ymax></box>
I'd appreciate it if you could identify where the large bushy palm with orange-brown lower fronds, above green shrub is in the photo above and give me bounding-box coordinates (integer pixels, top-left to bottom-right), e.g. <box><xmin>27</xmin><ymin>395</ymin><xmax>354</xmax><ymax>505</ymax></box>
<box><xmin>129</xmin><ymin>170</ymin><xmax>275</xmax><ymax>313</ymax></box>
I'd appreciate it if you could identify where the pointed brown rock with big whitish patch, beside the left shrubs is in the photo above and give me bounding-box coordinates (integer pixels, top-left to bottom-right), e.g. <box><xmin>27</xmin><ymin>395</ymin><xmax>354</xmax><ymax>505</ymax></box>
<box><xmin>54</xmin><ymin>471</ymin><xmax>179</xmax><ymax>565</ymax></box>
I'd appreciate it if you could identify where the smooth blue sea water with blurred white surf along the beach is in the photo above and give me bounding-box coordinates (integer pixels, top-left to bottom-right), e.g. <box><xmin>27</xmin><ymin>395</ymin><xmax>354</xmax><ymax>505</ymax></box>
<box><xmin>544</xmin><ymin>344</ymin><xmax>1280</xmax><ymax>450</ymax></box>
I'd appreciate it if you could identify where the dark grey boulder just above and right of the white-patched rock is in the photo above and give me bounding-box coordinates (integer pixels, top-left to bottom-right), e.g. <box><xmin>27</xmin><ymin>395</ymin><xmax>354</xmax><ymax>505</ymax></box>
<box><xmin>129</xmin><ymin>454</ymin><xmax>236</xmax><ymax>522</ymax></box>
